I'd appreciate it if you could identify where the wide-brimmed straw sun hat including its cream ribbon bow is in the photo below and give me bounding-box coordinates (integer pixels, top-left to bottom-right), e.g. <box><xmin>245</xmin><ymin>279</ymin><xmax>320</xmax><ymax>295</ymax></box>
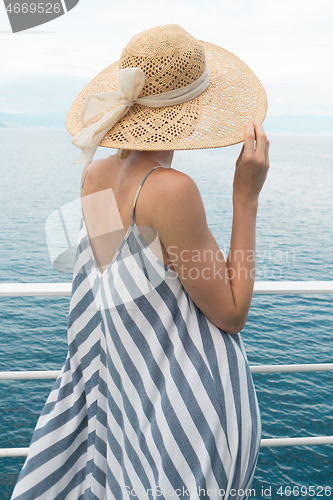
<box><xmin>65</xmin><ymin>24</ymin><xmax>267</xmax><ymax>163</ymax></box>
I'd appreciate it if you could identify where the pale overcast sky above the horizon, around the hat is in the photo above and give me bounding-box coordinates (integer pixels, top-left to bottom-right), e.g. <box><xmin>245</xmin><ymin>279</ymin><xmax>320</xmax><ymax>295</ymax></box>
<box><xmin>0</xmin><ymin>0</ymin><xmax>333</xmax><ymax>115</ymax></box>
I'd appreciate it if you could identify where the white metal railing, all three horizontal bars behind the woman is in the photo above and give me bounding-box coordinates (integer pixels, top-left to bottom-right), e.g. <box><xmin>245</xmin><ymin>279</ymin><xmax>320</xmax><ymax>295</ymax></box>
<box><xmin>0</xmin><ymin>281</ymin><xmax>333</xmax><ymax>457</ymax></box>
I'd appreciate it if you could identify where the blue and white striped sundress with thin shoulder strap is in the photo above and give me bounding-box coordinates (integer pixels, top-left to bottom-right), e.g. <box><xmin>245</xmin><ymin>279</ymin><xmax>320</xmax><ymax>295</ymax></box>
<box><xmin>12</xmin><ymin>167</ymin><xmax>261</xmax><ymax>500</ymax></box>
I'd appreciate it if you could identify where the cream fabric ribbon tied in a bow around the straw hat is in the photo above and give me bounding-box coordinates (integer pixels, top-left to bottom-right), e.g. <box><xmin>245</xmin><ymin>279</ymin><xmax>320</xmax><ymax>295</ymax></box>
<box><xmin>71</xmin><ymin>66</ymin><xmax>209</xmax><ymax>164</ymax></box>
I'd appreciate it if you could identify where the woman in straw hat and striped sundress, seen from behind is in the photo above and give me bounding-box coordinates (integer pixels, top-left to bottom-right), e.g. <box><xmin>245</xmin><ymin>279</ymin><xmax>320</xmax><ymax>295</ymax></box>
<box><xmin>12</xmin><ymin>25</ymin><xmax>269</xmax><ymax>500</ymax></box>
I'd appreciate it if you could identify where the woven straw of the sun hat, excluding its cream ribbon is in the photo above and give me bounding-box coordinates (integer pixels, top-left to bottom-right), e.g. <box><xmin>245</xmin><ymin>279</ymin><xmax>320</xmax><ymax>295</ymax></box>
<box><xmin>65</xmin><ymin>24</ymin><xmax>267</xmax><ymax>155</ymax></box>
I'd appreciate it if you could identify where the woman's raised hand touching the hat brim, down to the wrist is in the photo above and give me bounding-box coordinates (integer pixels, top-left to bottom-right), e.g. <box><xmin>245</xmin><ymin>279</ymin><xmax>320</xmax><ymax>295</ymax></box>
<box><xmin>233</xmin><ymin>120</ymin><xmax>269</xmax><ymax>204</ymax></box>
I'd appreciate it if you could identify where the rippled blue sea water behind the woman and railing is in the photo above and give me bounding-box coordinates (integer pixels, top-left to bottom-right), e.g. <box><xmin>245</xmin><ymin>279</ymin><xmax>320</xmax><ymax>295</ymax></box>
<box><xmin>0</xmin><ymin>128</ymin><xmax>333</xmax><ymax>500</ymax></box>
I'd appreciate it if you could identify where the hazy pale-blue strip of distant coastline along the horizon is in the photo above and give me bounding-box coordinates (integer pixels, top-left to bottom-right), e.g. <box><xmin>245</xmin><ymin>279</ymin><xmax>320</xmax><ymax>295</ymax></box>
<box><xmin>0</xmin><ymin>111</ymin><xmax>333</xmax><ymax>135</ymax></box>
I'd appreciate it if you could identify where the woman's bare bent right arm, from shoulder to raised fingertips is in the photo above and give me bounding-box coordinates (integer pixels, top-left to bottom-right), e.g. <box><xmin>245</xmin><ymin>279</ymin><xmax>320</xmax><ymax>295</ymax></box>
<box><xmin>151</xmin><ymin>122</ymin><xmax>269</xmax><ymax>333</ymax></box>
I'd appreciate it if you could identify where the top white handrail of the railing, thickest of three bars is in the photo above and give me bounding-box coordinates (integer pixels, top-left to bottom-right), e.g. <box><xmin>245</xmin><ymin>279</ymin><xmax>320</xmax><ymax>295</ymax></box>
<box><xmin>0</xmin><ymin>280</ymin><xmax>333</xmax><ymax>297</ymax></box>
